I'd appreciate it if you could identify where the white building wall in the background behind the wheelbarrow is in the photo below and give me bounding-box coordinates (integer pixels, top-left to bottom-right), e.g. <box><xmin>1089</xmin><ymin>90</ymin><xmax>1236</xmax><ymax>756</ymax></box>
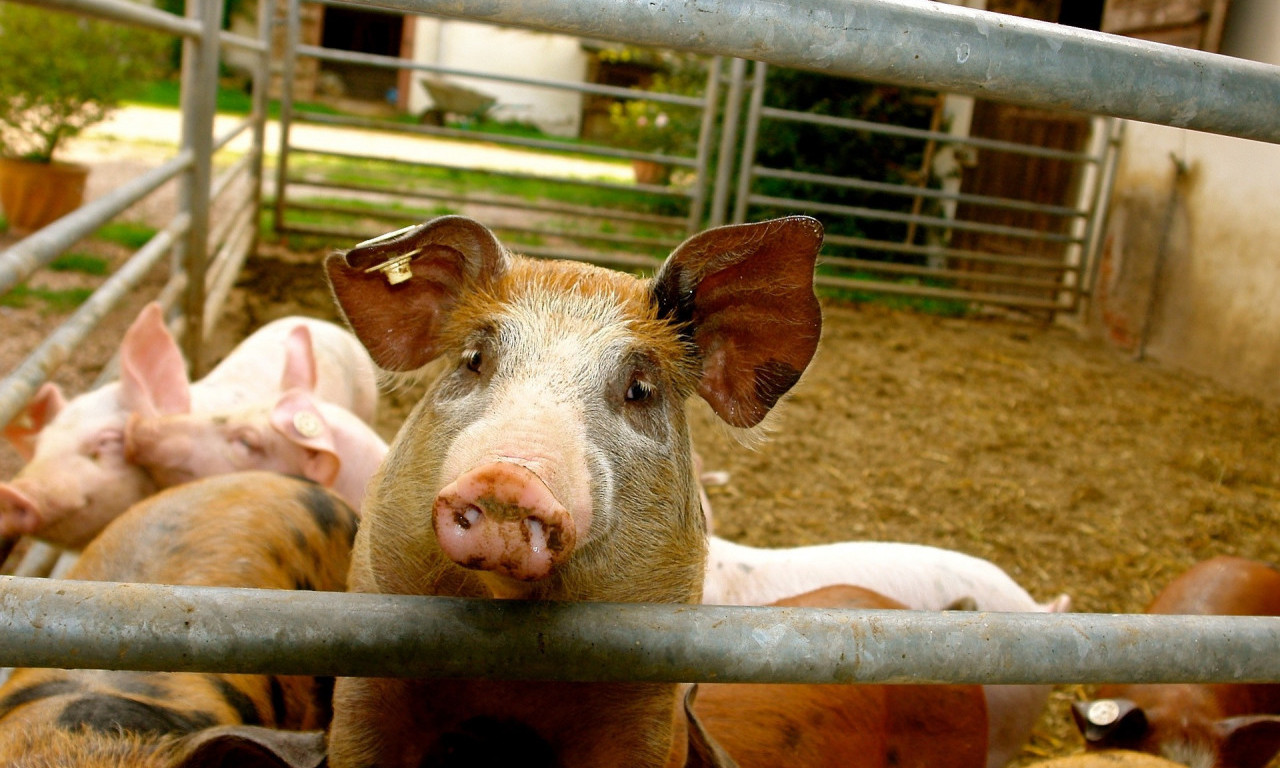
<box><xmin>410</xmin><ymin>18</ymin><xmax>588</xmax><ymax>136</ymax></box>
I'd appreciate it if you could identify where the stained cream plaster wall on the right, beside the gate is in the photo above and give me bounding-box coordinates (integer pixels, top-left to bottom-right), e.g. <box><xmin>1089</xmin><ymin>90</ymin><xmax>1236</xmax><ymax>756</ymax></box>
<box><xmin>1091</xmin><ymin>0</ymin><xmax>1280</xmax><ymax>402</ymax></box>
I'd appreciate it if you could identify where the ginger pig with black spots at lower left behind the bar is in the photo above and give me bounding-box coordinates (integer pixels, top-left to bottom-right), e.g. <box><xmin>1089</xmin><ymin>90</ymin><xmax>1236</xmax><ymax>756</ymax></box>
<box><xmin>0</xmin><ymin>472</ymin><xmax>356</xmax><ymax>768</ymax></box>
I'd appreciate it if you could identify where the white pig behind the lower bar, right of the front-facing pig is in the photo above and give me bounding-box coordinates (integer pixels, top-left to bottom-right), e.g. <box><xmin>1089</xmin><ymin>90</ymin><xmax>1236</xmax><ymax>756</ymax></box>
<box><xmin>703</xmin><ymin>536</ymin><xmax>1070</xmax><ymax>768</ymax></box>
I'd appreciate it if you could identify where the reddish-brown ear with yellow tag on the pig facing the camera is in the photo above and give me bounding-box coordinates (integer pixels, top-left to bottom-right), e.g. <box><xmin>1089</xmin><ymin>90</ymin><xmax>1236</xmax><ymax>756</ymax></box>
<box><xmin>325</xmin><ymin>216</ymin><xmax>509</xmax><ymax>372</ymax></box>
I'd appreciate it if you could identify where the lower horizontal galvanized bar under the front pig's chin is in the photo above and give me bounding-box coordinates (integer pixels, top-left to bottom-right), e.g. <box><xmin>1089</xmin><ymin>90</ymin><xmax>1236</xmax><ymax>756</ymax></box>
<box><xmin>0</xmin><ymin>576</ymin><xmax>1280</xmax><ymax>684</ymax></box>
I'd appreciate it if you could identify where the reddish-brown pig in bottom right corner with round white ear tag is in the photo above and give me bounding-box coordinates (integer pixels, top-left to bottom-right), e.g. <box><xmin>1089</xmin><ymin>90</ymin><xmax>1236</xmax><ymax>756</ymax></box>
<box><xmin>1071</xmin><ymin>556</ymin><xmax>1280</xmax><ymax>768</ymax></box>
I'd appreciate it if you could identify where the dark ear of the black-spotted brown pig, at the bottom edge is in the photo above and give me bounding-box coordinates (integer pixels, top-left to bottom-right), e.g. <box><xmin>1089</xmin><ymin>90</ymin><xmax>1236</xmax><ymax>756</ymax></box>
<box><xmin>174</xmin><ymin>726</ymin><xmax>328</xmax><ymax>768</ymax></box>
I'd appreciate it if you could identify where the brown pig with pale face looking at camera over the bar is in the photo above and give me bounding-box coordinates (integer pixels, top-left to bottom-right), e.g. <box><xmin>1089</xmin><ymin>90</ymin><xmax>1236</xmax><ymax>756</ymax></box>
<box><xmin>316</xmin><ymin>216</ymin><xmax>822</xmax><ymax>768</ymax></box>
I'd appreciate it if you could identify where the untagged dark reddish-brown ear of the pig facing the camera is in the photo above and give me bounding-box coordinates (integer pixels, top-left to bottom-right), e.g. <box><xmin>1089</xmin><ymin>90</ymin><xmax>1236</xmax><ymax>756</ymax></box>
<box><xmin>653</xmin><ymin>216</ymin><xmax>822</xmax><ymax>428</ymax></box>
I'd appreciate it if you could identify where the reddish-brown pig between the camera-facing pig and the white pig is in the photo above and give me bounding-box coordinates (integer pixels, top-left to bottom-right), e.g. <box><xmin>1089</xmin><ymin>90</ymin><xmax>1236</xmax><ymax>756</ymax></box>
<box><xmin>694</xmin><ymin>585</ymin><xmax>987</xmax><ymax>768</ymax></box>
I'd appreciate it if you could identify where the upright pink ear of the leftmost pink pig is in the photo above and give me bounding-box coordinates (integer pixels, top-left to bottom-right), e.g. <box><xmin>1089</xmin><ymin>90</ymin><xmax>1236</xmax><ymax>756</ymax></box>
<box><xmin>120</xmin><ymin>302</ymin><xmax>191</xmax><ymax>416</ymax></box>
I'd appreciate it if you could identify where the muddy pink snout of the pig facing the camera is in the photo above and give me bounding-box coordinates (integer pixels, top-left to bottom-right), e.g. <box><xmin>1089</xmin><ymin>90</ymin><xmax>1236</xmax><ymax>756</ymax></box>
<box><xmin>434</xmin><ymin>462</ymin><xmax>577</xmax><ymax>581</ymax></box>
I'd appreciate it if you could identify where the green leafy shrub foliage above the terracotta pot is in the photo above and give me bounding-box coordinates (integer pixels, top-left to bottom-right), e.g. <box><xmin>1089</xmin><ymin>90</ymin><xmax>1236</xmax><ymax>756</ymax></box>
<box><xmin>0</xmin><ymin>3</ymin><xmax>164</xmax><ymax>163</ymax></box>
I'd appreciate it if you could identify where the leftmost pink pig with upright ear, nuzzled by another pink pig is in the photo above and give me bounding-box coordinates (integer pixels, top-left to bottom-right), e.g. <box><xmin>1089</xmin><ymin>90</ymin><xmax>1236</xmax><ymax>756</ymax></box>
<box><xmin>0</xmin><ymin>303</ymin><xmax>378</xmax><ymax>549</ymax></box>
